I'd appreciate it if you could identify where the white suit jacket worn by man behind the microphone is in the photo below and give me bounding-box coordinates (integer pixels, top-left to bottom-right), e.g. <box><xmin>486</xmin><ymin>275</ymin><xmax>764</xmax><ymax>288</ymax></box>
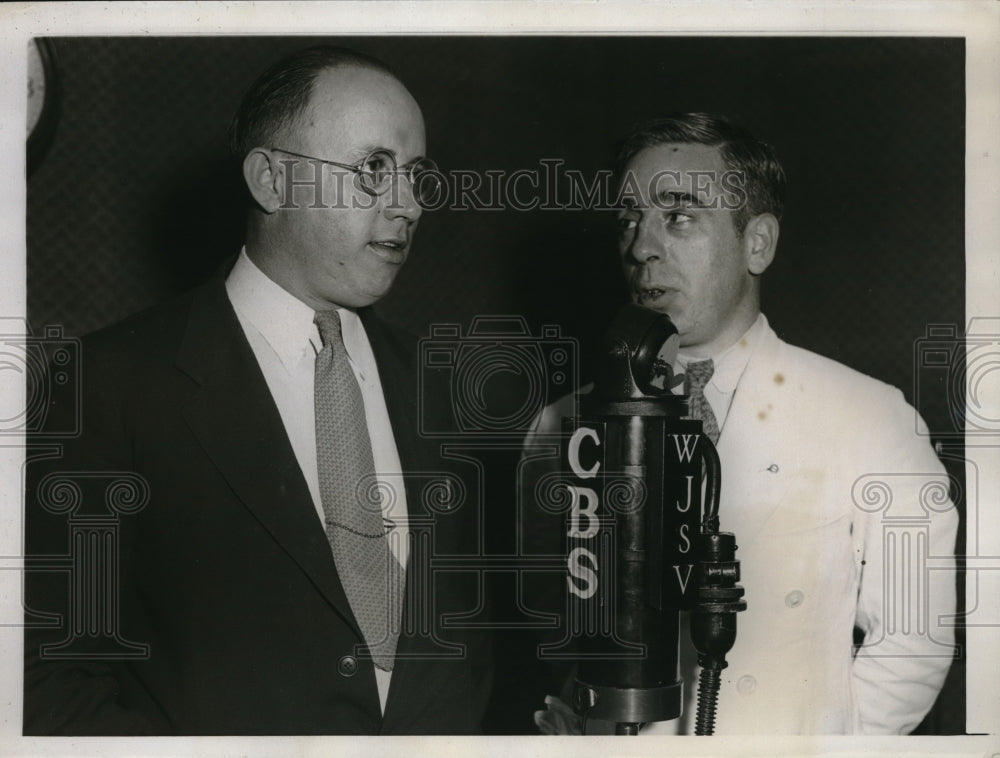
<box><xmin>528</xmin><ymin>323</ymin><xmax>958</xmax><ymax>734</ymax></box>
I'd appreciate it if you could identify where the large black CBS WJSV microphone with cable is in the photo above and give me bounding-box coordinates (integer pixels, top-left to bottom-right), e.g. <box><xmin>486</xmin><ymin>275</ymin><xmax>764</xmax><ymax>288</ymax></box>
<box><xmin>563</xmin><ymin>304</ymin><xmax>746</xmax><ymax>734</ymax></box>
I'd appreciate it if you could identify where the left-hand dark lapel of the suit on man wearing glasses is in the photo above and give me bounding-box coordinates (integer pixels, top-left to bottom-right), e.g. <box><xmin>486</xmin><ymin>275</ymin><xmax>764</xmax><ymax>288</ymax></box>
<box><xmin>177</xmin><ymin>280</ymin><xmax>363</xmax><ymax>639</ymax></box>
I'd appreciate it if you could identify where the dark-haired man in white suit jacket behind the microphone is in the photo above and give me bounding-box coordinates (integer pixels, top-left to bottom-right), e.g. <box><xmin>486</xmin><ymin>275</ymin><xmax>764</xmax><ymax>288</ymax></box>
<box><xmin>528</xmin><ymin>114</ymin><xmax>958</xmax><ymax>734</ymax></box>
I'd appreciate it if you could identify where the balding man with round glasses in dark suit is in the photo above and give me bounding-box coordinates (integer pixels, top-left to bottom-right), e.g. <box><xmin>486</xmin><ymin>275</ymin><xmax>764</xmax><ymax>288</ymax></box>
<box><xmin>24</xmin><ymin>47</ymin><xmax>489</xmax><ymax>734</ymax></box>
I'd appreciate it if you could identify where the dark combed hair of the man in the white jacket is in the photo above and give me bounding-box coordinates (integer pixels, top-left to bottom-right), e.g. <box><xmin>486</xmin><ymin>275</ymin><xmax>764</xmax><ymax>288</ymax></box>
<box><xmin>615</xmin><ymin>113</ymin><xmax>785</xmax><ymax>234</ymax></box>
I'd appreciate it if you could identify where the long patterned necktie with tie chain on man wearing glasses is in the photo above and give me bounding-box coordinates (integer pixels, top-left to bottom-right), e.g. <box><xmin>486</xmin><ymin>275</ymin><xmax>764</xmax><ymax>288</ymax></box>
<box><xmin>315</xmin><ymin>311</ymin><xmax>405</xmax><ymax>671</ymax></box>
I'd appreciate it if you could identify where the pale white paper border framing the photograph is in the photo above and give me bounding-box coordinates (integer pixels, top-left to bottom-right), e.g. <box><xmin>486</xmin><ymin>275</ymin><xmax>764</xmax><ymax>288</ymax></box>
<box><xmin>0</xmin><ymin>1</ymin><xmax>1000</xmax><ymax>756</ymax></box>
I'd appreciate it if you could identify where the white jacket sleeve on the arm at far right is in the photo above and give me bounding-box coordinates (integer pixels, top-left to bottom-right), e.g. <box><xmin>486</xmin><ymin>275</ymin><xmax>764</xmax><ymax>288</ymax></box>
<box><xmin>852</xmin><ymin>390</ymin><xmax>958</xmax><ymax>734</ymax></box>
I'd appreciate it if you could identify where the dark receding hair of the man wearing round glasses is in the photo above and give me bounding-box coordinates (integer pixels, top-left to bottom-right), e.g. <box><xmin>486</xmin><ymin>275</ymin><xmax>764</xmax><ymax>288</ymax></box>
<box><xmin>229</xmin><ymin>45</ymin><xmax>398</xmax><ymax>161</ymax></box>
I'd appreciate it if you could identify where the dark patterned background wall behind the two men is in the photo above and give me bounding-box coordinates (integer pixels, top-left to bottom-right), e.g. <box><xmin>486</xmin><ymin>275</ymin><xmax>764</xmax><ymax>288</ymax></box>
<box><xmin>27</xmin><ymin>37</ymin><xmax>965</xmax><ymax>731</ymax></box>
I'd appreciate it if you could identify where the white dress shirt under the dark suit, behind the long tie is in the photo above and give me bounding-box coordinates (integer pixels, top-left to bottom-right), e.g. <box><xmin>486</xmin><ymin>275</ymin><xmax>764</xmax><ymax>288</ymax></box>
<box><xmin>226</xmin><ymin>249</ymin><xmax>408</xmax><ymax>712</ymax></box>
